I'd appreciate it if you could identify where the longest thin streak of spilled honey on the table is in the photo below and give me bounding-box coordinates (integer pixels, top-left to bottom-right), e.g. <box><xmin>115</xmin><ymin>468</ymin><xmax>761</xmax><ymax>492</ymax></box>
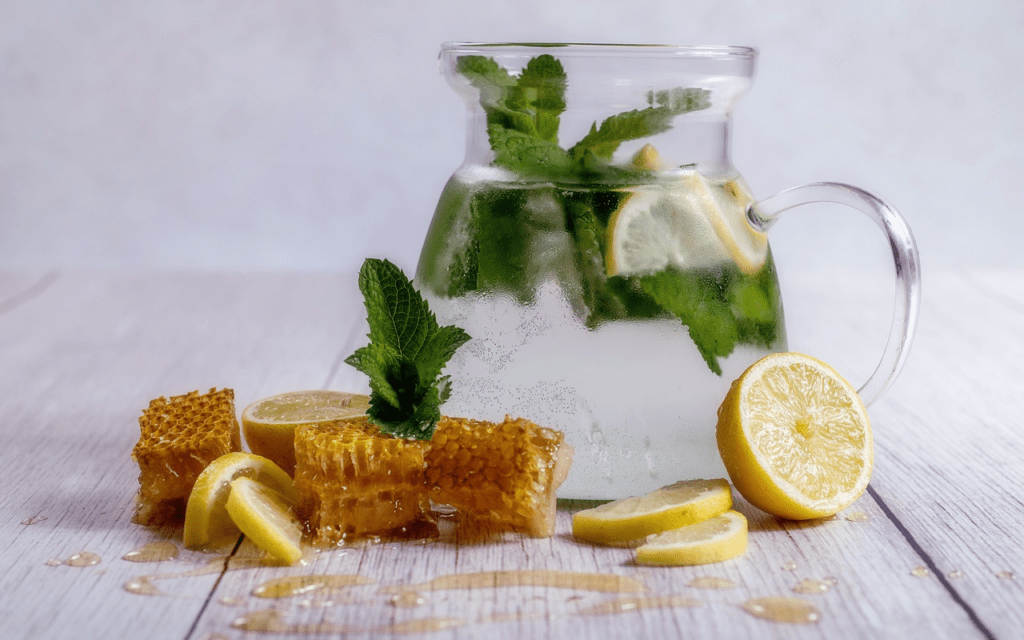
<box><xmin>381</xmin><ymin>569</ymin><xmax>647</xmax><ymax>594</ymax></box>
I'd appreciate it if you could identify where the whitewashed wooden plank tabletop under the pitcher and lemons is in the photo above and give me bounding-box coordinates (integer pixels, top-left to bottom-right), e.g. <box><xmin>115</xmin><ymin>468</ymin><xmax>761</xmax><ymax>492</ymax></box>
<box><xmin>0</xmin><ymin>267</ymin><xmax>1024</xmax><ymax>640</ymax></box>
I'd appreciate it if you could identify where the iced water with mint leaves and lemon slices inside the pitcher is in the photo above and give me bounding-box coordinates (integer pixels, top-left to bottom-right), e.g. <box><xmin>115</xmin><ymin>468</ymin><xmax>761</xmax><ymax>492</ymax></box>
<box><xmin>418</xmin><ymin>170</ymin><xmax>784</xmax><ymax>499</ymax></box>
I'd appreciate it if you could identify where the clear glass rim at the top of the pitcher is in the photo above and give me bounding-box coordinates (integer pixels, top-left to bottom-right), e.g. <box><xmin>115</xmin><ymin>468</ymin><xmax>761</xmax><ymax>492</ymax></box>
<box><xmin>440</xmin><ymin>42</ymin><xmax>758</xmax><ymax>59</ymax></box>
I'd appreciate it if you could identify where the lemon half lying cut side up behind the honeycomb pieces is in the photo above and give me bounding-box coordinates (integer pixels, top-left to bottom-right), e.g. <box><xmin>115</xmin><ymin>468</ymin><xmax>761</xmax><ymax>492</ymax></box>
<box><xmin>242</xmin><ymin>390</ymin><xmax>370</xmax><ymax>475</ymax></box>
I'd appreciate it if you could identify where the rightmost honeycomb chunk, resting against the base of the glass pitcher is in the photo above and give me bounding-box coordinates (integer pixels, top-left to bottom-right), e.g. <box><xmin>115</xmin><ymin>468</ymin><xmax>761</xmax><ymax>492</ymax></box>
<box><xmin>426</xmin><ymin>417</ymin><xmax>573</xmax><ymax>537</ymax></box>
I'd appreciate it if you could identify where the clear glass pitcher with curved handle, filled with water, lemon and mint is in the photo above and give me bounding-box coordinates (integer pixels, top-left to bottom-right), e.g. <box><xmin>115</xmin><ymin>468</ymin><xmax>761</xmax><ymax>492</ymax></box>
<box><xmin>416</xmin><ymin>43</ymin><xmax>920</xmax><ymax>499</ymax></box>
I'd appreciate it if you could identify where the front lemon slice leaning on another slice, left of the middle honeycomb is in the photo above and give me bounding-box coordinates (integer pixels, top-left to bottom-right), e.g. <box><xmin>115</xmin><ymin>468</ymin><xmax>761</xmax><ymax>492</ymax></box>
<box><xmin>227</xmin><ymin>477</ymin><xmax>302</xmax><ymax>564</ymax></box>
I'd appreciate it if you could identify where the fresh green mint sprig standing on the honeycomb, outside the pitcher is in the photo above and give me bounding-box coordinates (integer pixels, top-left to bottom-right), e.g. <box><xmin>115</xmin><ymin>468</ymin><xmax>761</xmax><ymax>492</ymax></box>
<box><xmin>345</xmin><ymin>258</ymin><xmax>470</xmax><ymax>440</ymax></box>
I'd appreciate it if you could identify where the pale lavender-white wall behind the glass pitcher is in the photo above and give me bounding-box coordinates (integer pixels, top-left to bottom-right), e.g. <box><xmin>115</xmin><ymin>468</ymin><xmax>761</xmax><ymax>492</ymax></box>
<box><xmin>0</xmin><ymin>0</ymin><xmax>1024</xmax><ymax>274</ymax></box>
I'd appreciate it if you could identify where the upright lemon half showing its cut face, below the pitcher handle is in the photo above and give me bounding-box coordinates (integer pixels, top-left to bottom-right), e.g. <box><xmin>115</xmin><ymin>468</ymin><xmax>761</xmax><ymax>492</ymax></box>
<box><xmin>717</xmin><ymin>353</ymin><xmax>873</xmax><ymax>520</ymax></box>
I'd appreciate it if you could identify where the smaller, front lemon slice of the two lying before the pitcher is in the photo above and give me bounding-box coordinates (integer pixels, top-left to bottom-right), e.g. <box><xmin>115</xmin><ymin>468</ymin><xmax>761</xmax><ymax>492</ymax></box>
<box><xmin>636</xmin><ymin>511</ymin><xmax>746</xmax><ymax>565</ymax></box>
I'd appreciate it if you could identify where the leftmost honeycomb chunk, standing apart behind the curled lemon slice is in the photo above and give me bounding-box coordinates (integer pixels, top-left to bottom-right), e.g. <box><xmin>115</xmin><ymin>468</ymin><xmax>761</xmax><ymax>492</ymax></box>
<box><xmin>131</xmin><ymin>389</ymin><xmax>242</xmax><ymax>524</ymax></box>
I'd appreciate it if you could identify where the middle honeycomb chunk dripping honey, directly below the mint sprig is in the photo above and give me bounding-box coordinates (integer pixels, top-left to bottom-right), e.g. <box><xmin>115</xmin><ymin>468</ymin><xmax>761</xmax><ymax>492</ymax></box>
<box><xmin>295</xmin><ymin>417</ymin><xmax>430</xmax><ymax>546</ymax></box>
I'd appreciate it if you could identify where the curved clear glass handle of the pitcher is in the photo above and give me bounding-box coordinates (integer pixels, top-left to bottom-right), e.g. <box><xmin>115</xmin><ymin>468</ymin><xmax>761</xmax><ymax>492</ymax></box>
<box><xmin>746</xmin><ymin>182</ymin><xmax>921</xmax><ymax>404</ymax></box>
